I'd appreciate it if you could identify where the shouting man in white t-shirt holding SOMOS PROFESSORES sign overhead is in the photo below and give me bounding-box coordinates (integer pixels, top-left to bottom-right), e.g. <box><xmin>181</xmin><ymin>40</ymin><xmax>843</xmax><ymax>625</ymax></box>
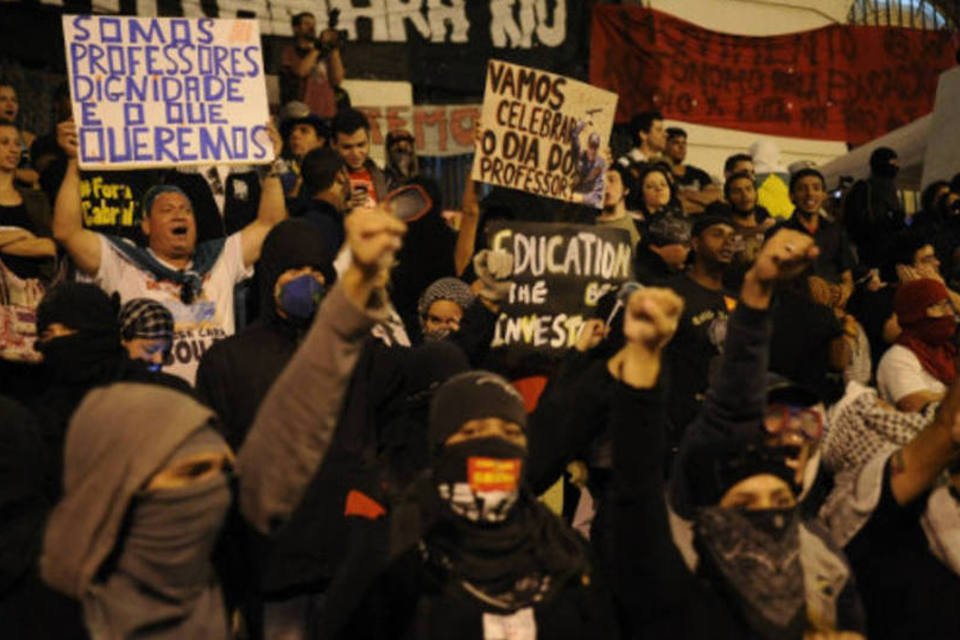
<box><xmin>53</xmin><ymin>121</ymin><xmax>287</xmax><ymax>384</ymax></box>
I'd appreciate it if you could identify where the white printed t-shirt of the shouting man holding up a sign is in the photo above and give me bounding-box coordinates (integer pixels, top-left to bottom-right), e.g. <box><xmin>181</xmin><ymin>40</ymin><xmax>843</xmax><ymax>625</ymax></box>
<box><xmin>93</xmin><ymin>232</ymin><xmax>253</xmax><ymax>384</ymax></box>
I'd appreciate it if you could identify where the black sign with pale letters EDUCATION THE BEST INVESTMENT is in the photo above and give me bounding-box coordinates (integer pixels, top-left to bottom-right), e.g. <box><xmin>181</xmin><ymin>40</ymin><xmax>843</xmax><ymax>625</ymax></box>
<box><xmin>487</xmin><ymin>221</ymin><xmax>633</xmax><ymax>356</ymax></box>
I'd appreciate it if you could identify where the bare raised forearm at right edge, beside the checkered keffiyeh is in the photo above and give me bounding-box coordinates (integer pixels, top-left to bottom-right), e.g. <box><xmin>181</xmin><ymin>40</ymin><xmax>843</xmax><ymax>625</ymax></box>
<box><xmin>888</xmin><ymin>382</ymin><xmax>960</xmax><ymax>505</ymax></box>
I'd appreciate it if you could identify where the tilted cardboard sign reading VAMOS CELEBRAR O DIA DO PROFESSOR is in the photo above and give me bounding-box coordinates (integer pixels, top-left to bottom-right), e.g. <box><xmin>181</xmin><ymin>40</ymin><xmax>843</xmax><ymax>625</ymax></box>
<box><xmin>473</xmin><ymin>60</ymin><xmax>617</xmax><ymax>208</ymax></box>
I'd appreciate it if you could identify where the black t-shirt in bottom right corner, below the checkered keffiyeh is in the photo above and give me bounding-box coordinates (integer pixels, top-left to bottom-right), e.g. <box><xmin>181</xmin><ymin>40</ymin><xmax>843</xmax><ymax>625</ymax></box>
<box><xmin>845</xmin><ymin>466</ymin><xmax>960</xmax><ymax>640</ymax></box>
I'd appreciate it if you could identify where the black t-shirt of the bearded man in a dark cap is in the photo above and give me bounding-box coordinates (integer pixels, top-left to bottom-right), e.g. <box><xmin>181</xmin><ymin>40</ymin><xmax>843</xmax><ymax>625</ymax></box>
<box><xmin>667</xmin><ymin>274</ymin><xmax>736</xmax><ymax>448</ymax></box>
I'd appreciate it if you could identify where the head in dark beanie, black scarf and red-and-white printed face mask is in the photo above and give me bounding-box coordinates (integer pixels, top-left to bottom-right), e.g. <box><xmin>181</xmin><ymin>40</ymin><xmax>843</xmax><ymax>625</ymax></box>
<box><xmin>420</xmin><ymin>371</ymin><xmax>590</xmax><ymax>613</ymax></box>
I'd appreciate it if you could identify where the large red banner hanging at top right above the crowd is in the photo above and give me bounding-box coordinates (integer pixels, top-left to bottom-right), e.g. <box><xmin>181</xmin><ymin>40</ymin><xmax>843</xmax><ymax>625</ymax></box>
<box><xmin>590</xmin><ymin>5</ymin><xmax>954</xmax><ymax>144</ymax></box>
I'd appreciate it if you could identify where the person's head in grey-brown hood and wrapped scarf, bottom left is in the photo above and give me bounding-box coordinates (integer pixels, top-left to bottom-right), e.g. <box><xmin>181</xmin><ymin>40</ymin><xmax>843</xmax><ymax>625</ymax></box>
<box><xmin>41</xmin><ymin>383</ymin><xmax>232</xmax><ymax>640</ymax></box>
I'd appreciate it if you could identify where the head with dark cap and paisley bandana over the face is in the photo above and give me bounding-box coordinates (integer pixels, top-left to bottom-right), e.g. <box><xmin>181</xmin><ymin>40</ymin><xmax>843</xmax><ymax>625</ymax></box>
<box><xmin>694</xmin><ymin>441</ymin><xmax>805</xmax><ymax>639</ymax></box>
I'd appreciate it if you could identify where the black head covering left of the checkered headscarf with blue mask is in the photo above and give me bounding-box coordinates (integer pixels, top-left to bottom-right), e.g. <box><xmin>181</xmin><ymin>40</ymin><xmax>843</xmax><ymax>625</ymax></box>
<box><xmin>36</xmin><ymin>282</ymin><xmax>127</xmax><ymax>383</ymax></box>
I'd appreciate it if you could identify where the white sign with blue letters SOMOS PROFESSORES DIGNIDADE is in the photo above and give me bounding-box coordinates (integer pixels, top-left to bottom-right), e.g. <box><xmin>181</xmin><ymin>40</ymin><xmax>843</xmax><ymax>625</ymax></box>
<box><xmin>63</xmin><ymin>16</ymin><xmax>273</xmax><ymax>169</ymax></box>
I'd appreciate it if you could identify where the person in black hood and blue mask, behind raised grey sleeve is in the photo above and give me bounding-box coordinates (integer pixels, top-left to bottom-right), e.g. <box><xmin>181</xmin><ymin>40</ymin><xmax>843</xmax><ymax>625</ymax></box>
<box><xmin>197</xmin><ymin>219</ymin><xmax>337</xmax><ymax>448</ymax></box>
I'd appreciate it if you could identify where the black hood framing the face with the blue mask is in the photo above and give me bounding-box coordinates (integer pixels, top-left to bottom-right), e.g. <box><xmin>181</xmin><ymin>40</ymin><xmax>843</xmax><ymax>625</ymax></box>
<box><xmin>257</xmin><ymin>219</ymin><xmax>337</xmax><ymax>330</ymax></box>
